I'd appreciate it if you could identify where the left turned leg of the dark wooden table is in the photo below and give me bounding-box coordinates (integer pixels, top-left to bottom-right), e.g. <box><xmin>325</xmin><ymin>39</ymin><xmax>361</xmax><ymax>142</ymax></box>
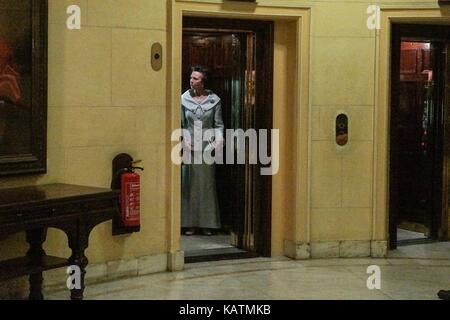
<box><xmin>26</xmin><ymin>228</ymin><xmax>47</xmax><ymax>300</ymax></box>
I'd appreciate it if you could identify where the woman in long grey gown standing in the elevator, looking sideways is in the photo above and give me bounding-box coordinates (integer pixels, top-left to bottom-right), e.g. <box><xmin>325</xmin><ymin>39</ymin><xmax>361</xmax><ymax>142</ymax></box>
<box><xmin>181</xmin><ymin>66</ymin><xmax>224</xmax><ymax>235</ymax></box>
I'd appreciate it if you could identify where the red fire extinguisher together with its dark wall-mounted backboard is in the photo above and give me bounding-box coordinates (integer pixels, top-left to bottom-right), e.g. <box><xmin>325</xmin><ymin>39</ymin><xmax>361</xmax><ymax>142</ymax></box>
<box><xmin>111</xmin><ymin>153</ymin><xmax>143</xmax><ymax>236</ymax></box>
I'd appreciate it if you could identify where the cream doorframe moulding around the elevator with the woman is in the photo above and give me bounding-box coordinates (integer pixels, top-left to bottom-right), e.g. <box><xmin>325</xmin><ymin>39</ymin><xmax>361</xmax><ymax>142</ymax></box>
<box><xmin>166</xmin><ymin>0</ymin><xmax>311</xmax><ymax>271</ymax></box>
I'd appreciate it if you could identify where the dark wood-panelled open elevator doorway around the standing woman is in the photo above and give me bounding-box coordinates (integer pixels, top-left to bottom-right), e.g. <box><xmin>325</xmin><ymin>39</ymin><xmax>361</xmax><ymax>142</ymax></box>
<box><xmin>181</xmin><ymin>17</ymin><xmax>273</xmax><ymax>262</ymax></box>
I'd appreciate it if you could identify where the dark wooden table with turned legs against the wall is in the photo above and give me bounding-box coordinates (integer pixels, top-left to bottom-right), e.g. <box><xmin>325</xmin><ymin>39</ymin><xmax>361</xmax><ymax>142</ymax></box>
<box><xmin>0</xmin><ymin>184</ymin><xmax>119</xmax><ymax>300</ymax></box>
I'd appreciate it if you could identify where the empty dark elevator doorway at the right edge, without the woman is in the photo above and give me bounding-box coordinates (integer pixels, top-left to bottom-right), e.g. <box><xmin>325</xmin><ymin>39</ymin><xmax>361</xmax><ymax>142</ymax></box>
<box><xmin>389</xmin><ymin>24</ymin><xmax>450</xmax><ymax>249</ymax></box>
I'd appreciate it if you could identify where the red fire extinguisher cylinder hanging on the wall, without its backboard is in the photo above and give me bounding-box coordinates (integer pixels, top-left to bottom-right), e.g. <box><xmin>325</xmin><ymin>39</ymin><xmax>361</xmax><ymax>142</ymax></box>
<box><xmin>120</xmin><ymin>166</ymin><xmax>144</xmax><ymax>228</ymax></box>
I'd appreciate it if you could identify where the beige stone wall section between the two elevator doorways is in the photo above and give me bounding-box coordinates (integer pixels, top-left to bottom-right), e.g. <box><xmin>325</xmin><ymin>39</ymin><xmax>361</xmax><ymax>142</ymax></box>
<box><xmin>311</xmin><ymin>1</ymin><xmax>375</xmax><ymax>241</ymax></box>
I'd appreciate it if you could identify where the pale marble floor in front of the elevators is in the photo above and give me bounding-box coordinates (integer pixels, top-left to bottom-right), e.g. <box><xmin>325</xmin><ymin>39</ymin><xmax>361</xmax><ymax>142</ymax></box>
<box><xmin>46</xmin><ymin>242</ymin><xmax>450</xmax><ymax>300</ymax></box>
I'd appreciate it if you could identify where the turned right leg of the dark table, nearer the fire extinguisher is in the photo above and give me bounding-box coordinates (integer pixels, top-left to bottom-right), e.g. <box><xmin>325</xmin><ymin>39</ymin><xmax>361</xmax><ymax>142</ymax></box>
<box><xmin>69</xmin><ymin>227</ymin><xmax>89</xmax><ymax>300</ymax></box>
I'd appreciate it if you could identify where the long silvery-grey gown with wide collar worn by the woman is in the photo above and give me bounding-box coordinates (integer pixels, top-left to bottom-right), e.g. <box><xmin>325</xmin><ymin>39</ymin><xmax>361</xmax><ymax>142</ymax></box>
<box><xmin>181</xmin><ymin>90</ymin><xmax>224</xmax><ymax>229</ymax></box>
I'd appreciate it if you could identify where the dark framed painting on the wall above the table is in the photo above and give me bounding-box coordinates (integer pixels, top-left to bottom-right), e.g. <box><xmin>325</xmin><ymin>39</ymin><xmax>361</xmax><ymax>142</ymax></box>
<box><xmin>0</xmin><ymin>0</ymin><xmax>48</xmax><ymax>176</ymax></box>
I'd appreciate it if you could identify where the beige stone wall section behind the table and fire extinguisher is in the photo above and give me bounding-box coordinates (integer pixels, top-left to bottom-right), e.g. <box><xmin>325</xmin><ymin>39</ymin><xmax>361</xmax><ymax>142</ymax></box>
<box><xmin>0</xmin><ymin>0</ymin><xmax>166</xmax><ymax>263</ymax></box>
